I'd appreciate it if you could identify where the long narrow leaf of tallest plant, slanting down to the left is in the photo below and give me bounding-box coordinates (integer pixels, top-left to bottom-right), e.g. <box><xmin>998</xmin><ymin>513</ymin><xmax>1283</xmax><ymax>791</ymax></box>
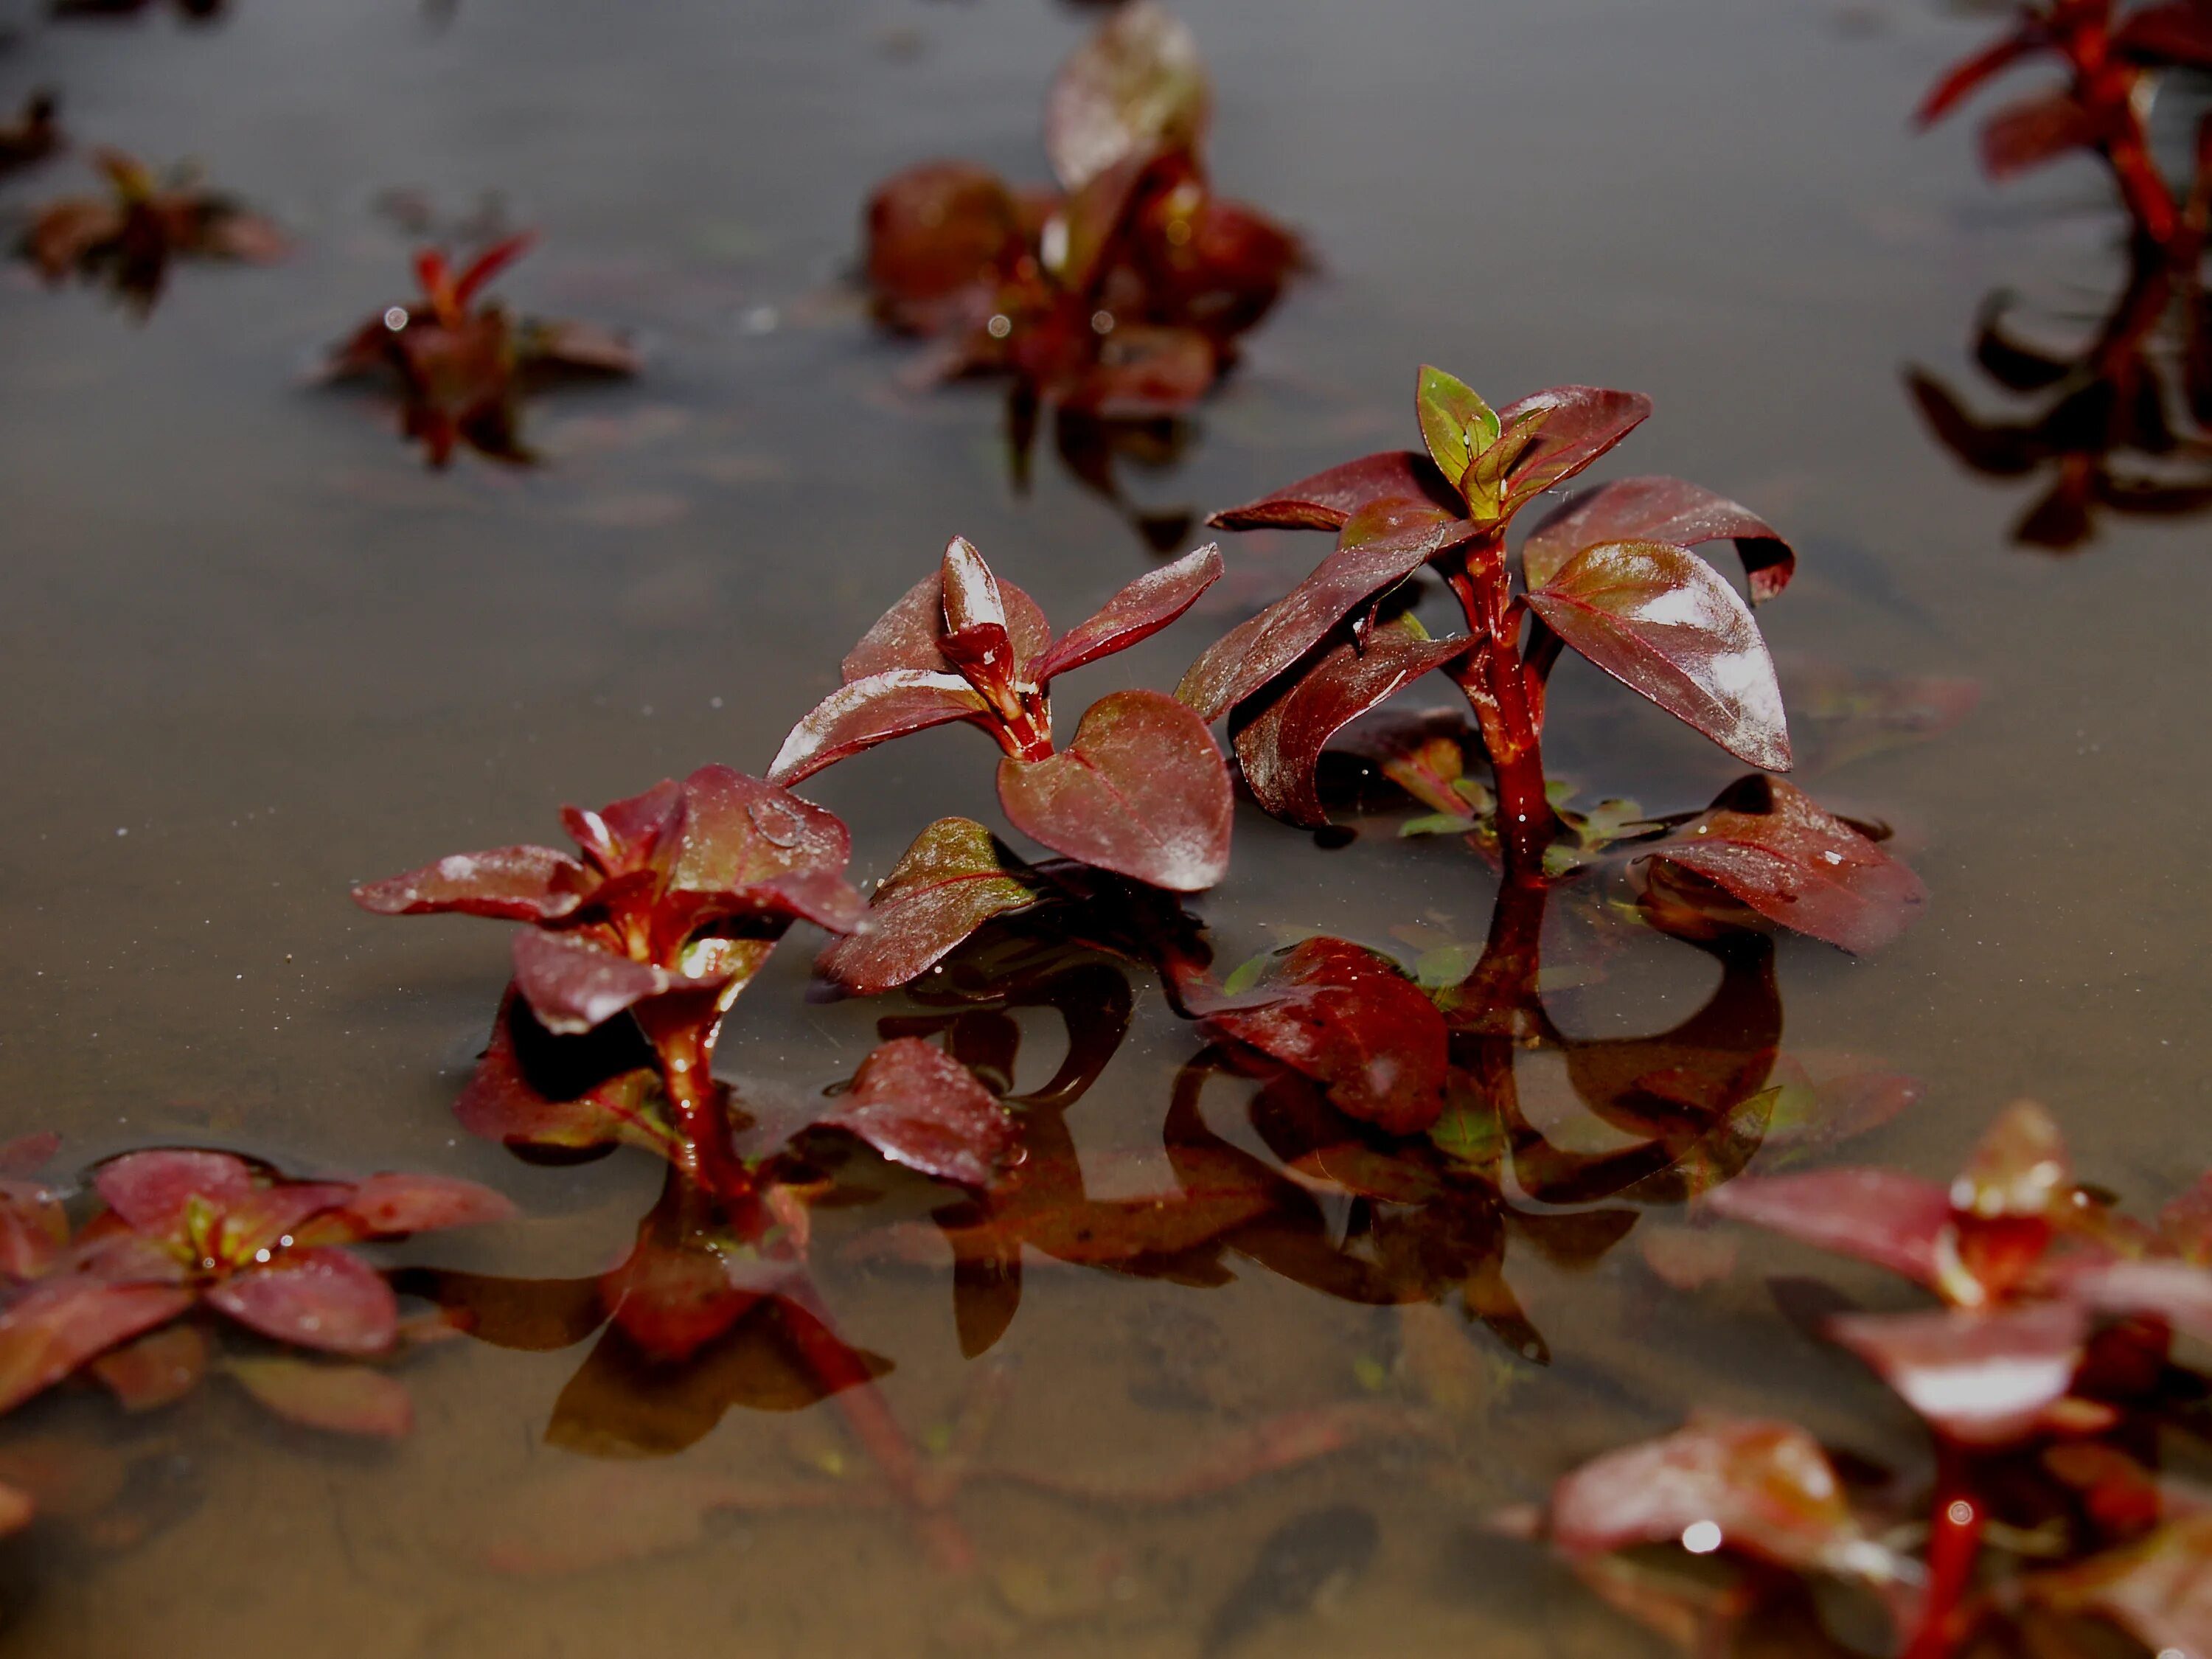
<box><xmin>1175</xmin><ymin>495</ymin><xmax>1471</xmax><ymax>721</ymax></box>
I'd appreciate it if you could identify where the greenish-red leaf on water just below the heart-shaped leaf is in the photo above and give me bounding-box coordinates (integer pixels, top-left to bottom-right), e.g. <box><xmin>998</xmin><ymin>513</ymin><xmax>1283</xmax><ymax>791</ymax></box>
<box><xmin>816</xmin><ymin>818</ymin><xmax>1042</xmax><ymax>995</ymax></box>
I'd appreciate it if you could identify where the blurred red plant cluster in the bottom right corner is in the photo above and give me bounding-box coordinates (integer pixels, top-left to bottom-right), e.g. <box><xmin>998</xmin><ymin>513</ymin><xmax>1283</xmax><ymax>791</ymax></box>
<box><xmin>1522</xmin><ymin>1104</ymin><xmax>2212</xmax><ymax>1659</ymax></box>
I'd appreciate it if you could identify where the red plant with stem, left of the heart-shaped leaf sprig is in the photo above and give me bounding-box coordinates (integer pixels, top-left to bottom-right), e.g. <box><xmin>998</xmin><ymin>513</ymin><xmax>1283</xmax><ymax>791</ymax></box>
<box><xmin>354</xmin><ymin>765</ymin><xmax>865</xmax><ymax>1203</ymax></box>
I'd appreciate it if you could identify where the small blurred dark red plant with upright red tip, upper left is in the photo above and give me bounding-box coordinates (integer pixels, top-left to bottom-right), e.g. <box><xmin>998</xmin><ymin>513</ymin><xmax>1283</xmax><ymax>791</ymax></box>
<box><xmin>323</xmin><ymin>234</ymin><xmax>637</xmax><ymax>467</ymax></box>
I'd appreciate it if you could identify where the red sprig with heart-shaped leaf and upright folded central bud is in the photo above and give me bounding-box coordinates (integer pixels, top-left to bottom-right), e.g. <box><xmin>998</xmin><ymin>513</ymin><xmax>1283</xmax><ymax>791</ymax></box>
<box><xmin>770</xmin><ymin>538</ymin><xmax>1230</xmax><ymax>894</ymax></box>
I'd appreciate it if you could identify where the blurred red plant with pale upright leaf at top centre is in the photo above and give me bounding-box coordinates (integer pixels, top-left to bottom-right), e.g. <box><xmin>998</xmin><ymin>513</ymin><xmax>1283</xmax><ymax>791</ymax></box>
<box><xmin>867</xmin><ymin>0</ymin><xmax>1301</xmax><ymax>551</ymax></box>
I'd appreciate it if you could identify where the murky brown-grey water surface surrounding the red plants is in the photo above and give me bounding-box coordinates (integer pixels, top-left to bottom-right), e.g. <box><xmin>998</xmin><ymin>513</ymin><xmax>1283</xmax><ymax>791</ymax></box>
<box><xmin>0</xmin><ymin>0</ymin><xmax>2212</xmax><ymax>1659</ymax></box>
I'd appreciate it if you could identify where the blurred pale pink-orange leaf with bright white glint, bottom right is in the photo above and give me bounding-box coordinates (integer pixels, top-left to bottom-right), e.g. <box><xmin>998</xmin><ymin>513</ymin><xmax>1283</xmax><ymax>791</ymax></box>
<box><xmin>1551</xmin><ymin>1418</ymin><xmax>1889</xmax><ymax>1575</ymax></box>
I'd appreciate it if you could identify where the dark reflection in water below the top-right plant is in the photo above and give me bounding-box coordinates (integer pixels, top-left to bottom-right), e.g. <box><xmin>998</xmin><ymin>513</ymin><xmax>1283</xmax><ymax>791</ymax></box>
<box><xmin>1907</xmin><ymin>241</ymin><xmax>2212</xmax><ymax>553</ymax></box>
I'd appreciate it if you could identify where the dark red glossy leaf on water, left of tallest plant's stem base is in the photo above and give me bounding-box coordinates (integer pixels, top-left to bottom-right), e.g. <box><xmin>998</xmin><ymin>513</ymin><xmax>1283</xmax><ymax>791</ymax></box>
<box><xmin>1206</xmin><ymin>938</ymin><xmax>1449</xmax><ymax>1135</ymax></box>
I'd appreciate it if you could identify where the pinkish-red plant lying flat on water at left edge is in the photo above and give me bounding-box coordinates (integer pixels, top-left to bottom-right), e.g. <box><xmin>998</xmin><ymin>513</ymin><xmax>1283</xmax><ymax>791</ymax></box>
<box><xmin>0</xmin><ymin>1150</ymin><xmax>513</xmax><ymax>1433</ymax></box>
